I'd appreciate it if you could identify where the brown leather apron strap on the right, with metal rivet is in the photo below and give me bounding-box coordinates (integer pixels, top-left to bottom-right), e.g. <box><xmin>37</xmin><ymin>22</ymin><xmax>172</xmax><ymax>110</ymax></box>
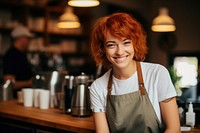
<box><xmin>136</xmin><ymin>61</ymin><xmax>145</xmax><ymax>95</ymax></box>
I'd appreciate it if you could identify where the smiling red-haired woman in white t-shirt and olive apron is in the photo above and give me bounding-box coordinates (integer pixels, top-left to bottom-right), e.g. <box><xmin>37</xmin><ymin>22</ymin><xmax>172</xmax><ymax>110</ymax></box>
<box><xmin>90</xmin><ymin>13</ymin><xmax>180</xmax><ymax>133</ymax></box>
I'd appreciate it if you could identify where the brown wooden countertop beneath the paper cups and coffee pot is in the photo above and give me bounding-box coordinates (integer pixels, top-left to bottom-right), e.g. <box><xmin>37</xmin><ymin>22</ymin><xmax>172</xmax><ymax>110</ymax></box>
<box><xmin>0</xmin><ymin>100</ymin><xmax>95</xmax><ymax>133</ymax></box>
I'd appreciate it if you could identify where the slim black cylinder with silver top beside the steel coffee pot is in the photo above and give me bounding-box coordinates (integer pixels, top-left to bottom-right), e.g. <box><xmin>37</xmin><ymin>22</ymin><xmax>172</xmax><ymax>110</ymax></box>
<box><xmin>64</xmin><ymin>75</ymin><xmax>74</xmax><ymax>114</ymax></box>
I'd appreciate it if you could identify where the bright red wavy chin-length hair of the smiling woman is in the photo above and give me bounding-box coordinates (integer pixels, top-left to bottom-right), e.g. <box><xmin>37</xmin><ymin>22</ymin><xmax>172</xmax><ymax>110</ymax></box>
<box><xmin>91</xmin><ymin>13</ymin><xmax>147</xmax><ymax>66</ymax></box>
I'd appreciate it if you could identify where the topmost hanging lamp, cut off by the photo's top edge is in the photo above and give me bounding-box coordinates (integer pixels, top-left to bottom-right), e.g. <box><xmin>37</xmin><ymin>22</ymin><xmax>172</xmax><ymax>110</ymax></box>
<box><xmin>68</xmin><ymin>0</ymin><xmax>100</xmax><ymax>7</ymax></box>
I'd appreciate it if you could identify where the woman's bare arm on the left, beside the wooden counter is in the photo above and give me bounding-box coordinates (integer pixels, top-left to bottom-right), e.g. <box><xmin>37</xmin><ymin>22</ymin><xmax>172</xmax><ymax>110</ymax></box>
<box><xmin>93</xmin><ymin>112</ymin><xmax>109</xmax><ymax>133</ymax></box>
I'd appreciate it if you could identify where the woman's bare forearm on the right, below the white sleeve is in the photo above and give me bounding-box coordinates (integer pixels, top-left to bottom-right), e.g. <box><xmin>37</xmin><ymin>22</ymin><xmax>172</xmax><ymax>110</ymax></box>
<box><xmin>160</xmin><ymin>97</ymin><xmax>181</xmax><ymax>133</ymax></box>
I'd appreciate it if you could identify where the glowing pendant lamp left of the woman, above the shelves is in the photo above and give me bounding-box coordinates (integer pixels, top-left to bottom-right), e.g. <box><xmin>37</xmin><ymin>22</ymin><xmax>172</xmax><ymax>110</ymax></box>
<box><xmin>57</xmin><ymin>7</ymin><xmax>81</xmax><ymax>28</ymax></box>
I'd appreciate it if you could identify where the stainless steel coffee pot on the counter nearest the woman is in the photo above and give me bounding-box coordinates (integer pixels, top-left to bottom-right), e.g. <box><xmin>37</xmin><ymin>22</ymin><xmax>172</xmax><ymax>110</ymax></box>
<box><xmin>71</xmin><ymin>73</ymin><xmax>91</xmax><ymax>116</ymax></box>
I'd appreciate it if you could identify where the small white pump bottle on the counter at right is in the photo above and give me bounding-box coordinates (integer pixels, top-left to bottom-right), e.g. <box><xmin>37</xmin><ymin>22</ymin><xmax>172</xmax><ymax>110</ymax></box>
<box><xmin>186</xmin><ymin>102</ymin><xmax>195</xmax><ymax>127</ymax></box>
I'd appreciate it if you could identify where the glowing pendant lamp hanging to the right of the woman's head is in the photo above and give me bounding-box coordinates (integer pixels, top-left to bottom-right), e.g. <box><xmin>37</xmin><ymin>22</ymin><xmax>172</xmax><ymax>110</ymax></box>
<box><xmin>151</xmin><ymin>7</ymin><xmax>176</xmax><ymax>32</ymax></box>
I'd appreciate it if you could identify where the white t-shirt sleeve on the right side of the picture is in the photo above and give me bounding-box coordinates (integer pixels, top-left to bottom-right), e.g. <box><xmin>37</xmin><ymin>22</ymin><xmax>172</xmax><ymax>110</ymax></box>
<box><xmin>156</xmin><ymin>65</ymin><xmax>176</xmax><ymax>102</ymax></box>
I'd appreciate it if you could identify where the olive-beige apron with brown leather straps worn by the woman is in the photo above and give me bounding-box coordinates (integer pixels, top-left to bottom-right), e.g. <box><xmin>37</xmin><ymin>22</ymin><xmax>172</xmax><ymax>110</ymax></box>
<box><xmin>106</xmin><ymin>62</ymin><xmax>164</xmax><ymax>133</ymax></box>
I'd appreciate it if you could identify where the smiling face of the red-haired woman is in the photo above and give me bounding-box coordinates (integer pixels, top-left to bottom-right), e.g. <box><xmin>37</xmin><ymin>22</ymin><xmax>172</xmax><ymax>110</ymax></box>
<box><xmin>104</xmin><ymin>32</ymin><xmax>134</xmax><ymax>69</ymax></box>
